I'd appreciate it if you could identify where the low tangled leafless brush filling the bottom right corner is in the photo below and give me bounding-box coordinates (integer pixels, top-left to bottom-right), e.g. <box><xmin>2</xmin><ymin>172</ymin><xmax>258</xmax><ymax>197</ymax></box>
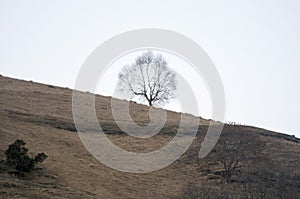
<box><xmin>179</xmin><ymin>166</ymin><xmax>300</xmax><ymax>199</ymax></box>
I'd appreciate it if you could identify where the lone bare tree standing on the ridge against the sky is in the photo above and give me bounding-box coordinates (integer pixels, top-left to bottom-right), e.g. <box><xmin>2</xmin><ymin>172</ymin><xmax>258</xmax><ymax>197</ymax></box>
<box><xmin>118</xmin><ymin>51</ymin><xmax>176</xmax><ymax>106</ymax></box>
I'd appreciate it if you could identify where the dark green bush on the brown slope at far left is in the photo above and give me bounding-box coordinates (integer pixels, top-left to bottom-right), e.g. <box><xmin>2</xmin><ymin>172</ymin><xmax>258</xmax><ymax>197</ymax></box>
<box><xmin>5</xmin><ymin>140</ymin><xmax>48</xmax><ymax>174</ymax></box>
